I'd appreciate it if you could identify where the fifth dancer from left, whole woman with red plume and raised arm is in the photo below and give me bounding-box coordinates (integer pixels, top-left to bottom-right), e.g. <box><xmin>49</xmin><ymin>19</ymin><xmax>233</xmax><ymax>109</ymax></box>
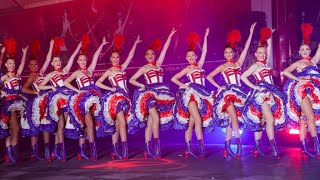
<box><xmin>96</xmin><ymin>35</ymin><xmax>141</xmax><ymax>160</ymax></box>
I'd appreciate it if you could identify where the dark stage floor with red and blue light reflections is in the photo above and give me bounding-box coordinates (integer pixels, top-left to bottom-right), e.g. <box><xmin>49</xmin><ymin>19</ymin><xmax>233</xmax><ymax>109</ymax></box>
<box><xmin>0</xmin><ymin>144</ymin><xmax>320</xmax><ymax>180</ymax></box>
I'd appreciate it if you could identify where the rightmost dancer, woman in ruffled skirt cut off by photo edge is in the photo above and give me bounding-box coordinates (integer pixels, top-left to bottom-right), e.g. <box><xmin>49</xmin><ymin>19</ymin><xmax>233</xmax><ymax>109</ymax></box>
<box><xmin>283</xmin><ymin>24</ymin><xmax>320</xmax><ymax>158</ymax></box>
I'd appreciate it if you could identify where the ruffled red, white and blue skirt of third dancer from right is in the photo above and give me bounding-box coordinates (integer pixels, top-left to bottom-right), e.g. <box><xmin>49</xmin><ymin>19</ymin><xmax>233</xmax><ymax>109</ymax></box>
<box><xmin>213</xmin><ymin>84</ymin><xmax>247</xmax><ymax>129</ymax></box>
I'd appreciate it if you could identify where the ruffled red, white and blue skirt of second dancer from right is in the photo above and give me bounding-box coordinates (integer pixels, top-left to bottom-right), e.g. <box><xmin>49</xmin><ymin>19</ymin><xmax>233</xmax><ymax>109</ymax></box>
<box><xmin>243</xmin><ymin>82</ymin><xmax>286</xmax><ymax>131</ymax></box>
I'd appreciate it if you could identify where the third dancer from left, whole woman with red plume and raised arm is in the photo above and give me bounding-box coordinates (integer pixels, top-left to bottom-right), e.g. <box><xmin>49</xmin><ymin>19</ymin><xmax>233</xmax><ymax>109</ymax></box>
<box><xmin>39</xmin><ymin>37</ymin><xmax>81</xmax><ymax>161</ymax></box>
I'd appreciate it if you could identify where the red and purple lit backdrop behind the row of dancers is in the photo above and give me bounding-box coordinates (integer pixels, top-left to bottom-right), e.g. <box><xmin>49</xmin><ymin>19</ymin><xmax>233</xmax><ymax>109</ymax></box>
<box><xmin>0</xmin><ymin>0</ymin><xmax>296</xmax><ymax>146</ymax></box>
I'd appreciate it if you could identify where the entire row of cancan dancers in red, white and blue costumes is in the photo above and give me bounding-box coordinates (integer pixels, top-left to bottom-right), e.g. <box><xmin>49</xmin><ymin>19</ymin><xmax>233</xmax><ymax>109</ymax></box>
<box><xmin>0</xmin><ymin>23</ymin><xmax>320</xmax><ymax>162</ymax></box>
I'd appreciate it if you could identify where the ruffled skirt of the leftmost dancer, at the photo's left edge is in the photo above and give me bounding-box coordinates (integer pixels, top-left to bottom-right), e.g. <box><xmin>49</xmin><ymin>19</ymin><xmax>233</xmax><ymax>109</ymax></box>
<box><xmin>0</xmin><ymin>88</ymin><xmax>26</xmax><ymax>139</ymax></box>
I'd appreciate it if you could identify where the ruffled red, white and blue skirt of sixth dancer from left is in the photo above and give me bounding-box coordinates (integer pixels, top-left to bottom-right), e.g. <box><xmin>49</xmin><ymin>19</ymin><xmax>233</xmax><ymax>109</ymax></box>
<box><xmin>129</xmin><ymin>83</ymin><xmax>175</xmax><ymax>132</ymax></box>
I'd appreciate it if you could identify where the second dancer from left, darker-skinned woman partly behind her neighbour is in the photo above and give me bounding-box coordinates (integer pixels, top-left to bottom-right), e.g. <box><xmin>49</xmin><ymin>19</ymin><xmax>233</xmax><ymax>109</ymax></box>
<box><xmin>21</xmin><ymin>40</ymin><xmax>54</xmax><ymax>161</ymax></box>
